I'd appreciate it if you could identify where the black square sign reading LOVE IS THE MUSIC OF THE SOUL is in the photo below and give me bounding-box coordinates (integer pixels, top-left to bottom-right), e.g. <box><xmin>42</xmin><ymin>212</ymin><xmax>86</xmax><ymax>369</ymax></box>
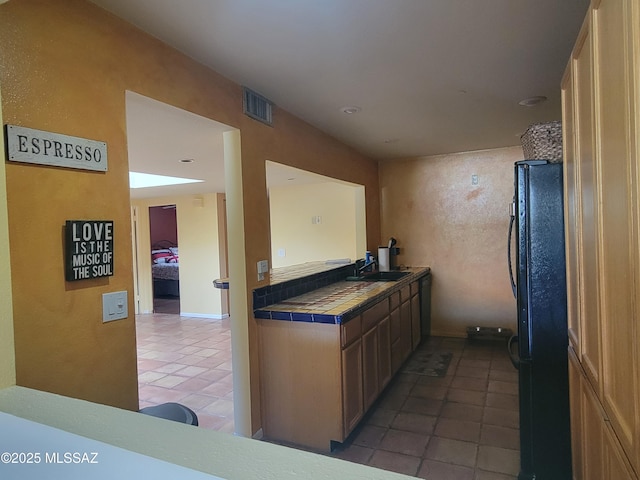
<box><xmin>65</xmin><ymin>220</ymin><xmax>113</xmax><ymax>282</ymax></box>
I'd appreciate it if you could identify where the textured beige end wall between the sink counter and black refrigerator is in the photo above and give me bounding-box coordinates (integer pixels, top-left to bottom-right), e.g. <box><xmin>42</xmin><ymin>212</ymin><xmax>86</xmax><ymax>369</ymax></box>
<box><xmin>380</xmin><ymin>147</ymin><xmax>523</xmax><ymax>336</ymax></box>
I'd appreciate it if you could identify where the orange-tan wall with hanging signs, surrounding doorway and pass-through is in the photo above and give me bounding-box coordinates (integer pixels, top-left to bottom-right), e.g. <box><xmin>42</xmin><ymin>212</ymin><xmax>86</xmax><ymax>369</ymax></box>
<box><xmin>0</xmin><ymin>0</ymin><xmax>380</xmax><ymax>431</ymax></box>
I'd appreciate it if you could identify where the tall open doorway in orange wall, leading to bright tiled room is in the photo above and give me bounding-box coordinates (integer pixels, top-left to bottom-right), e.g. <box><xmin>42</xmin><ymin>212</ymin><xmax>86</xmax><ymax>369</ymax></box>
<box><xmin>126</xmin><ymin>92</ymin><xmax>250</xmax><ymax>435</ymax></box>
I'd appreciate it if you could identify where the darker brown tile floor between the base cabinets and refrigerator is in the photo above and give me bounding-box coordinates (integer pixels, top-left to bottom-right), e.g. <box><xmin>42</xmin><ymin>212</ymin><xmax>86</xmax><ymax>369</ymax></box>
<box><xmin>332</xmin><ymin>337</ymin><xmax>520</xmax><ymax>480</ymax></box>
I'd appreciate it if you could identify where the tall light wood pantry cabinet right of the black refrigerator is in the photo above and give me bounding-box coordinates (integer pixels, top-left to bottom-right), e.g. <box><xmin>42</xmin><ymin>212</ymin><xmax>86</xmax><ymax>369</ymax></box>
<box><xmin>562</xmin><ymin>0</ymin><xmax>640</xmax><ymax>479</ymax></box>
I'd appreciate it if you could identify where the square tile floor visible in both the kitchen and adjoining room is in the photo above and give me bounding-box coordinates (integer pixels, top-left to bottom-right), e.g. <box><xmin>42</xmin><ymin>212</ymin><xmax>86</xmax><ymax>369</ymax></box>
<box><xmin>136</xmin><ymin>314</ymin><xmax>519</xmax><ymax>480</ymax></box>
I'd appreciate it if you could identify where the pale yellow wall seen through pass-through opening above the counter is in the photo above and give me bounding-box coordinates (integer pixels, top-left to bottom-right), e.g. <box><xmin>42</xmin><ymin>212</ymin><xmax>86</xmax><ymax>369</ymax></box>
<box><xmin>269</xmin><ymin>182</ymin><xmax>365</xmax><ymax>268</ymax></box>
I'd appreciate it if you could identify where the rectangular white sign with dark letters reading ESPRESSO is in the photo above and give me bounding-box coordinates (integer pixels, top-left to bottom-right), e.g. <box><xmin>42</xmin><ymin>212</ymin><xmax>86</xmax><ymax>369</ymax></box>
<box><xmin>6</xmin><ymin>125</ymin><xmax>107</xmax><ymax>172</ymax></box>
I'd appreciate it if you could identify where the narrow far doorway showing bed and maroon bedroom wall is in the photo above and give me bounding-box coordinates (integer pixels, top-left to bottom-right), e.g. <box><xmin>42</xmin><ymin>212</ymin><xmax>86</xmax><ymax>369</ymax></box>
<box><xmin>149</xmin><ymin>204</ymin><xmax>180</xmax><ymax>314</ymax></box>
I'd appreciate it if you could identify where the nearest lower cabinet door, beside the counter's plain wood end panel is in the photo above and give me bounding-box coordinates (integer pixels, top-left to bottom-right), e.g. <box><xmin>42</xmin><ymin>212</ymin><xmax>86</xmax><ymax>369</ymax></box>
<box><xmin>342</xmin><ymin>339</ymin><xmax>364</xmax><ymax>438</ymax></box>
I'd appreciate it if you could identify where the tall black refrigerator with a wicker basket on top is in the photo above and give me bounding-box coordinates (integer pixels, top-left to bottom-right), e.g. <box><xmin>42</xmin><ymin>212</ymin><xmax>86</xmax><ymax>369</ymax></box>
<box><xmin>508</xmin><ymin>160</ymin><xmax>572</xmax><ymax>480</ymax></box>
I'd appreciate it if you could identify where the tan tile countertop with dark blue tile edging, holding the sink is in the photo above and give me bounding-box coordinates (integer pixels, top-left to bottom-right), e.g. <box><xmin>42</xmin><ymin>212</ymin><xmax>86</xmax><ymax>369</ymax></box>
<box><xmin>254</xmin><ymin>267</ymin><xmax>431</xmax><ymax>324</ymax></box>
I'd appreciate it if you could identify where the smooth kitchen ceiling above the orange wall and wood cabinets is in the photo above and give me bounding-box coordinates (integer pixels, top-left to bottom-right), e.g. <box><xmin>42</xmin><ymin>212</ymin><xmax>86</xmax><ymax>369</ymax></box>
<box><xmin>97</xmin><ymin>0</ymin><xmax>589</xmax><ymax>197</ymax></box>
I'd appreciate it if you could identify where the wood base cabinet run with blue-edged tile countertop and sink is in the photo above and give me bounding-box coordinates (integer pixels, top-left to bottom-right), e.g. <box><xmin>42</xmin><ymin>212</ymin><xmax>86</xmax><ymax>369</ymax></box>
<box><xmin>254</xmin><ymin>266</ymin><xmax>430</xmax><ymax>451</ymax></box>
